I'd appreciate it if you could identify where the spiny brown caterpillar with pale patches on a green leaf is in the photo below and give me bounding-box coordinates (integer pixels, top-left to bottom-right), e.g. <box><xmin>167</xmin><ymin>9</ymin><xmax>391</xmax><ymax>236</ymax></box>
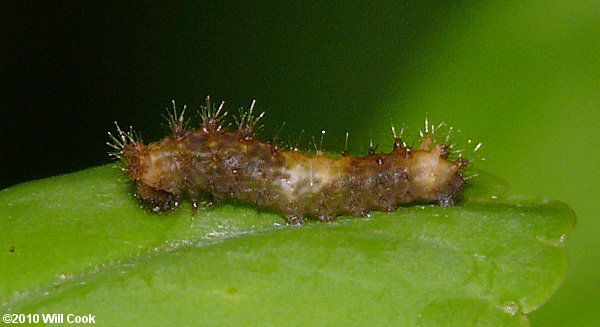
<box><xmin>107</xmin><ymin>97</ymin><xmax>468</xmax><ymax>224</ymax></box>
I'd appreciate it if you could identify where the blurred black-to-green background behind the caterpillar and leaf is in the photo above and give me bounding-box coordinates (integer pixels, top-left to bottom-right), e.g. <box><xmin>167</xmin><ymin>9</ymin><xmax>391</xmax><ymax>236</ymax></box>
<box><xmin>0</xmin><ymin>0</ymin><xmax>600</xmax><ymax>326</ymax></box>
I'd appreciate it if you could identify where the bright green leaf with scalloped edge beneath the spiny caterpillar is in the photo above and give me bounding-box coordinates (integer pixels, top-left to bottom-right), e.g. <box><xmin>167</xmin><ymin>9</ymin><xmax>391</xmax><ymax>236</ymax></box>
<box><xmin>0</xmin><ymin>166</ymin><xmax>575</xmax><ymax>326</ymax></box>
